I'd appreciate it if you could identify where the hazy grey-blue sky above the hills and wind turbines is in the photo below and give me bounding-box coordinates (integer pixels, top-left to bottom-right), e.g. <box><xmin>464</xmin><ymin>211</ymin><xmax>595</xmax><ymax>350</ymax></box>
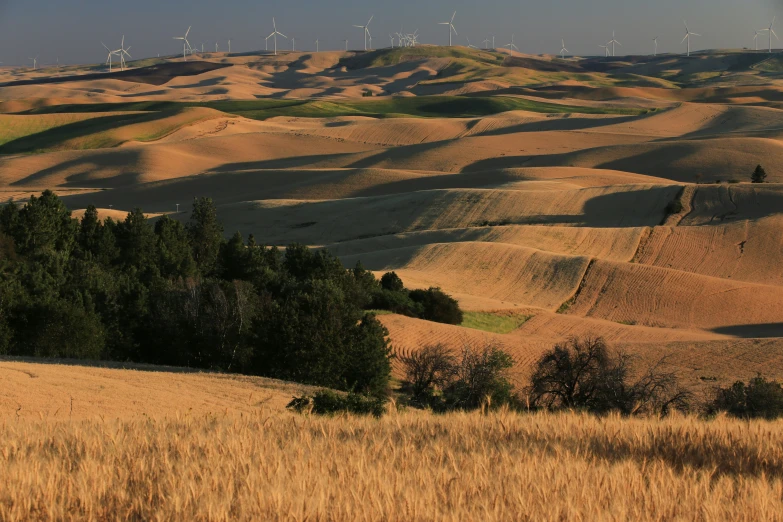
<box><xmin>0</xmin><ymin>0</ymin><xmax>783</xmax><ymax>65</ymax></box>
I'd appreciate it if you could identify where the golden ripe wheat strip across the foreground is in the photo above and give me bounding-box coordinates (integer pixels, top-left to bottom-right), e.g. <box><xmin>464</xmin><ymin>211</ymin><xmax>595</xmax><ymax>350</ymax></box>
<box><xmin>0</xmin><ymin>407</ymin><xmax>783</xmax><ymax>521</ymax></box>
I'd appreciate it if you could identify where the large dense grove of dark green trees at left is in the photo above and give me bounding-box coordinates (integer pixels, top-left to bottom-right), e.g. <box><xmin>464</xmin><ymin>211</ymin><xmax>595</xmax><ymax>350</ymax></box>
<box><xmin>0</xmin><ymin>192</ymin><xmax>391</xmax><ymax>398</ymax></box>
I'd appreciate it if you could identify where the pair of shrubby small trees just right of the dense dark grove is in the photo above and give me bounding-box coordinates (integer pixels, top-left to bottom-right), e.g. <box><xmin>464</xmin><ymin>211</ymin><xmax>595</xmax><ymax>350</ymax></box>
<box><xmin>400</xmin><ymin>343</ymin><xmax>516</xmax><ymax>411</ymax></box>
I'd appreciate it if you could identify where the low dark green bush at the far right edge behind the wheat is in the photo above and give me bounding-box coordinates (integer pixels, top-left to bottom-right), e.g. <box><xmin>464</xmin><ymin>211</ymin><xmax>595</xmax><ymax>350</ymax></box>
<box><xmin>706</xmin><ymin>375</ymin><xmax>783</xmax><ymax>420</ymax></box>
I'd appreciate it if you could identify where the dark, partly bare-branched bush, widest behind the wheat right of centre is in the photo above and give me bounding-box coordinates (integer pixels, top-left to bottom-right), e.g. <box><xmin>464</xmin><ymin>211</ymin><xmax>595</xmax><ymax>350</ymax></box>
<box><xmin>528</xmin><ymin>337</ymin><xmax>690</xmax><ymax>415</ymax></box>
